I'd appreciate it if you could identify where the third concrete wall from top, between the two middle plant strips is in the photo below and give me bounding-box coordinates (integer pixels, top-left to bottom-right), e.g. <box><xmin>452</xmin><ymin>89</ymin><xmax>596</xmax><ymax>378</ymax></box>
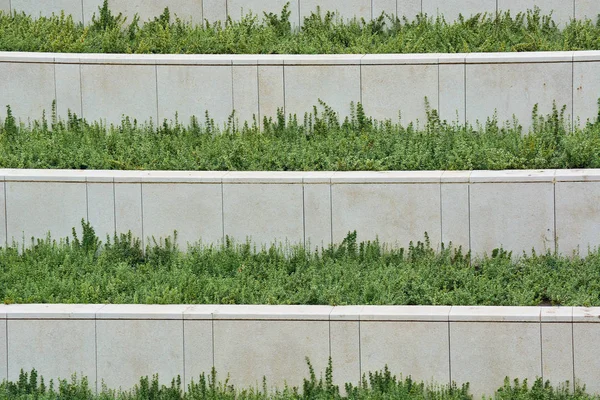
<box><xmin>0</xmin><ymin>170</ymin><xmax>600</xmax><ymax>254</ymax></box>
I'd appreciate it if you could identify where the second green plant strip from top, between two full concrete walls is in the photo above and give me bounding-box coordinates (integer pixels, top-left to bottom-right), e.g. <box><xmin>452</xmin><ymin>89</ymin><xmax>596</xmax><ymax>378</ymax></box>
<box><xmin>0</xmin><ymin>104</ymin><xmax>600</xmax><ymax>171</ymax></box>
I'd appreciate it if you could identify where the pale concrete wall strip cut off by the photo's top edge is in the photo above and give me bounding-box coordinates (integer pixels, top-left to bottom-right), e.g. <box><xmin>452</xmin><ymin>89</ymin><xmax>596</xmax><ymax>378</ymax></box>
<box><xmin>0</xmin><ymin>0</ymin><xmax>600</xmax><ymax>25</ymax></box>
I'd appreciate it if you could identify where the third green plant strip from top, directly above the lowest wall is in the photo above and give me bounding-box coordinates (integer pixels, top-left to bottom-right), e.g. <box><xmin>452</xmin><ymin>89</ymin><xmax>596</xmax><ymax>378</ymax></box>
<box><xmin>0</xmin><ymin>220</ymin><xmax>600</xmax><ymax>306</ymax></box>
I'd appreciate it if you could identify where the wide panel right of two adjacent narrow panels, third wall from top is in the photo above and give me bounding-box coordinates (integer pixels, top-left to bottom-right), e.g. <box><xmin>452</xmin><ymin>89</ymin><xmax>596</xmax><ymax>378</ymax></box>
<box><xmin>143</xmin><ymin>183</ymin><xmax>223</xmax><ymax>249</ymax></box>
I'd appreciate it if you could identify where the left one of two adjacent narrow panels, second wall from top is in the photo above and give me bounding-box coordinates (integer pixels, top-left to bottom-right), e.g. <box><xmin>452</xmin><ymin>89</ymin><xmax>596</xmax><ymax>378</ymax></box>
<box><xmin>233</xmin><ymin>65</ymin><xmax>260</xmax><ymax>125</ymax></box>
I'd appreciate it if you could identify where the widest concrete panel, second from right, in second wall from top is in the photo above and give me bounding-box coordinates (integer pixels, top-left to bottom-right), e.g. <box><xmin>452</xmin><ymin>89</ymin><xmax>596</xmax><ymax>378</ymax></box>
<box><xmin>466</xmin><ymin>61</ymin><xmax>573</xmax><ymax>130</ymax></box>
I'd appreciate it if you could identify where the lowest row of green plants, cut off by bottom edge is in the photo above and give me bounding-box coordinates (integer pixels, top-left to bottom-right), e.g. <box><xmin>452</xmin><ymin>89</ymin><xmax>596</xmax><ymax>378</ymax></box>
<box><xmin>0</xmin><ymin>361</ymin><xmax>599</xmax><ymax>400</ymax></box>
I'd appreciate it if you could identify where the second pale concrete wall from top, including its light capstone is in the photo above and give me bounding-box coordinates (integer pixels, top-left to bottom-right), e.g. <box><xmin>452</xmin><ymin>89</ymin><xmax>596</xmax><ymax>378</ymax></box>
<box><xmin>0</xmin><ymin>51</ymin><xmax>600</xmax><ymax>128</ymax></box>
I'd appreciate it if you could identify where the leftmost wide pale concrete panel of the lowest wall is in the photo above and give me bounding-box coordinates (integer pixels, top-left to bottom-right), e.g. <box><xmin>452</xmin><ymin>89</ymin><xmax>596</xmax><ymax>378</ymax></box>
<box><xmin>8</xmin><ymin>318</ymin><xmax>96</xmax><ymax>387</ymax></box>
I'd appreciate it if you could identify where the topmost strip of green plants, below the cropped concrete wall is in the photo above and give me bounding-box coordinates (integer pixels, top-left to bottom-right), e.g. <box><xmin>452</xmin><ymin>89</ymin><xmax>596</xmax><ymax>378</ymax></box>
<box><xmin>0</xmin><ymin>2</ymin><xmax>600</xmax><ymax>54</ymax></box>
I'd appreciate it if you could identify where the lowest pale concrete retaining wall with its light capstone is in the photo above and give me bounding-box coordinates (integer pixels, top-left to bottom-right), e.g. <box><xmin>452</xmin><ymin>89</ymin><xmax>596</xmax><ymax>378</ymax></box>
<box><xmin>0</xmin><ymin>304</ymin><xmax>600</xmax><ymax>398</ymax></box>
